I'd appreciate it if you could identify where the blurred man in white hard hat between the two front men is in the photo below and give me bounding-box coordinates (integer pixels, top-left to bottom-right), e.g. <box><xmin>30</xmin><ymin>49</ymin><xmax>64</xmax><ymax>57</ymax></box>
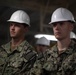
<box><xmin>29</xmin><ymin>37</ymin><xmax>50</xmax><ymax>75</ymax></box>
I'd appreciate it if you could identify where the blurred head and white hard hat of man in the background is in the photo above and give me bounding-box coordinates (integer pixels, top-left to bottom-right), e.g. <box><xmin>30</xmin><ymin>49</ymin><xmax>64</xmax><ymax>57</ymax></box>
<box><xmin>35</xmin><ymin>37</ymin><xmax>50</xmax><ymax>53</ymax></box>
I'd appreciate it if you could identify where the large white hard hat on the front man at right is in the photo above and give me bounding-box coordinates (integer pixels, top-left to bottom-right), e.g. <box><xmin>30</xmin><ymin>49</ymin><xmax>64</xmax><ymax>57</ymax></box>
<box><xmin>49</xmin><ymin>8</ymin><xmax>75</xmax><ymax>24</ymax></box>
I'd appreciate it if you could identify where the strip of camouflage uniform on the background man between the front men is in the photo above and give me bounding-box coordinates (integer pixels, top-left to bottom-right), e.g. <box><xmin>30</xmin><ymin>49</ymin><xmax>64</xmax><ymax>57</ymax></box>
<box><xmin>29</xmin><ymin>49</ymin><xmax>49</xmax><ymax>75</ymax></box>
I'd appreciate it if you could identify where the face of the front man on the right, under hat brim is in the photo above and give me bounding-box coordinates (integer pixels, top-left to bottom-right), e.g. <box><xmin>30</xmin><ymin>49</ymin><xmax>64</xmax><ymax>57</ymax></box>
<box><xmin>53</xmin><ymin>21</ymin><xmax>73</xmax><ymax>40</ymax></box>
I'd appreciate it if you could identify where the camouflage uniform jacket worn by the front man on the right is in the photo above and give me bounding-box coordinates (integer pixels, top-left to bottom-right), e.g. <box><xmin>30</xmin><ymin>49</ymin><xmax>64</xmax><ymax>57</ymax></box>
<box><xmin>41</xmin><ymin>40</ymin><xmax>76</xmax><ymax>75</ymax></box>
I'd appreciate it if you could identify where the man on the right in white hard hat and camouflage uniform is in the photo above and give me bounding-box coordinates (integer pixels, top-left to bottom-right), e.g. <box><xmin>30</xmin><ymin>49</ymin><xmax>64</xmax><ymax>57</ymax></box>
<box><xmin>42</xmin><ymin>8</ymin><xmax>76</xmax><ymax>75</ymax></box>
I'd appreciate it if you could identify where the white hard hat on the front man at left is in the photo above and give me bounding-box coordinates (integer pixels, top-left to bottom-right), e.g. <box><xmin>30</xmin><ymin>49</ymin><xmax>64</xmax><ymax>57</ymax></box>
<box><xmin>8</xmin><ymin>10</ymin><xmax>30</xmax><ymax>26</ymax></box>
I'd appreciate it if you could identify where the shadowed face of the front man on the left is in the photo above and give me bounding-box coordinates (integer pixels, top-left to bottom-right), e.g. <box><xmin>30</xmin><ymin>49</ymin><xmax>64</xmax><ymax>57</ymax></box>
<box><xmin>10</xmin><ymin>23</ymin><xmax>26</xmax><ymax>38</ymax></box>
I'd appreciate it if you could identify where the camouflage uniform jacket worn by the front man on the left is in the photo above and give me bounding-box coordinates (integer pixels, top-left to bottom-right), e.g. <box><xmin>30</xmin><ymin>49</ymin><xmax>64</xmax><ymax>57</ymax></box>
<box><xmin>0</xmin><ymin>41</ymin><xmax>36</xmax><ymax>75</ymax></box>
